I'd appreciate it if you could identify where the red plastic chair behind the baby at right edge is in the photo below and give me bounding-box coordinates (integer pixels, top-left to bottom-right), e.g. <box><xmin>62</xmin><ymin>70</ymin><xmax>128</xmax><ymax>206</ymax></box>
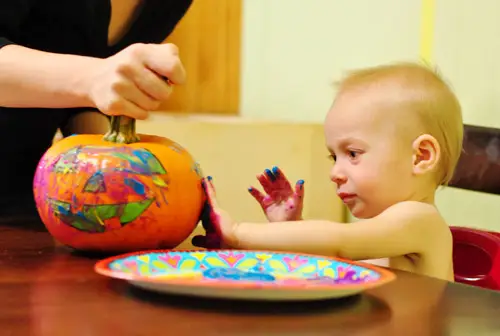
<box><xmin>450</xmin><ymin>226</ymin><xmax>500</xmax><ymax>290</ymax></box>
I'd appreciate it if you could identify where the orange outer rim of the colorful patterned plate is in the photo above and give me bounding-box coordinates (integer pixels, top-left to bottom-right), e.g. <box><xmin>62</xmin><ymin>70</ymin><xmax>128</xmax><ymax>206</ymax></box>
<box><xmin>94</xmin><ymin>249</ymin><xmax>397</xmax><ymax>291</ymax></box>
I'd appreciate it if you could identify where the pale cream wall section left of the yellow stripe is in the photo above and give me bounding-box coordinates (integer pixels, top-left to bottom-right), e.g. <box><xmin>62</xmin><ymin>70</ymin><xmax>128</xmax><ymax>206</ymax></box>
<box><xmin>240</xmin><ymin>0</ymin><xmax>421</xmax><ymax>122</ymax></box>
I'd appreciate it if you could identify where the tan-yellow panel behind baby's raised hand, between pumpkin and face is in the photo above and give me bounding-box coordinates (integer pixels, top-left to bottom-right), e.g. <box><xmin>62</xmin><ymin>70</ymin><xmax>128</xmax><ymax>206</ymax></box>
<box><xmin>137</xmin><ymin>114</ymin><xmax>346</xmax><ymax>247</ymax></box>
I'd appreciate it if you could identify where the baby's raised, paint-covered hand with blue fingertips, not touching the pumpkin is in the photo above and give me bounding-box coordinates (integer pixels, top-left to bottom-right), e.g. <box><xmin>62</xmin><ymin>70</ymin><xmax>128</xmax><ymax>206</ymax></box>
<box><xmin>248</xmin><ymin>167</ymin><xmax>304</xmax><ymax>222</ymax></box>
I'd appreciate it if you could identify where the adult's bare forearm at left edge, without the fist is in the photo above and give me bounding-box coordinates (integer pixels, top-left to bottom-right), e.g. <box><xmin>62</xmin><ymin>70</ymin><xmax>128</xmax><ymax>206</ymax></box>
<box><xmin>0</xmin><ymin>45</ymin><xmax>102</xmax><ymax>108</ymax></box>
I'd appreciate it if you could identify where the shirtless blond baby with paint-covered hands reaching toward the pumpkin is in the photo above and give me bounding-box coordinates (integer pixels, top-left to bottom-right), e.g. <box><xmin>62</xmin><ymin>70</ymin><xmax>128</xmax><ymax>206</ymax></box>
<box><xmin>193</xmin><ymin>63</ymin><xmax>463</xmax><ymax>281</ymax></box>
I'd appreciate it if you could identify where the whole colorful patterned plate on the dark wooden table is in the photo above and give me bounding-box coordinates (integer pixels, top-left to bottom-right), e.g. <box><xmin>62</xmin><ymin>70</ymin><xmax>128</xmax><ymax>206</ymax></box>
<box><xmin>95</xmin><ymin>250</ymin><xmax>396</xmax><ymax>300</ymax></box>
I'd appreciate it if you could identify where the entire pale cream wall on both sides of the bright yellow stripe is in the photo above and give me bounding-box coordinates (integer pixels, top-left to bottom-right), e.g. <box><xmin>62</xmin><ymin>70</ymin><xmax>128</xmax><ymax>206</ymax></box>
<box><xmin>237</xmin><ymin>0</ymin><xmax>500</xmax><ymax>231</ymax></box>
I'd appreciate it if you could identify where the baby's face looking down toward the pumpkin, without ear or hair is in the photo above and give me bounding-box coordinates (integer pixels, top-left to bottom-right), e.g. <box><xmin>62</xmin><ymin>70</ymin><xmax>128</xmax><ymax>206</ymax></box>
<box><xmin>325</xmin><ymin>92</ymin><xmax>418</xmax><ymax>218</ymax></box>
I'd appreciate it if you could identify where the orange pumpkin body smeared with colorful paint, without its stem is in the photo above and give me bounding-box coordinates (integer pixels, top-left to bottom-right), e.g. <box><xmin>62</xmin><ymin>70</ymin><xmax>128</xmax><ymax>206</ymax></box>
<box><xmin>33</xmin><ymin>135</ymin><xmax>205</xmax><ymax>252</ymax></box>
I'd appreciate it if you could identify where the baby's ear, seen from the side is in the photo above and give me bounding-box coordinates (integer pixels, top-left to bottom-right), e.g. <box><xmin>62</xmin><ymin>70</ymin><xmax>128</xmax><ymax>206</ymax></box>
<box><xmin>413</xmin><ymin>134</ymin><xmax>441</xmax><ymax>175</ymax></box>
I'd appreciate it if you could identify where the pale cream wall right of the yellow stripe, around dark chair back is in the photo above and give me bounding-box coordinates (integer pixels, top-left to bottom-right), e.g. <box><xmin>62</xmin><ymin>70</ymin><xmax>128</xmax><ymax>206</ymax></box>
<box><xmin>433</xmin><ymin>0</ymin><xmax>500</xmax><ymax>231</ymax></box>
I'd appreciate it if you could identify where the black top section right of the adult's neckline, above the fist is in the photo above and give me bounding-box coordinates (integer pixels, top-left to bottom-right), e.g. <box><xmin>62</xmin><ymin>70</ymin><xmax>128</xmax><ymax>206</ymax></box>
<box><xmin>109</xmin><ymin>0</ymin><xmax>193</xmax><ymax>54</ymax></box>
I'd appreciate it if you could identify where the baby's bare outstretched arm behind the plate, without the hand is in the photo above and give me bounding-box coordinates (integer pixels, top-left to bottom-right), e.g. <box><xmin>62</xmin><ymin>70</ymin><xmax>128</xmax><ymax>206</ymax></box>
<box><xmin>229</xmin><ymin>202</ymin><xmax>440</xmax><ymax>260</ymax></box>
